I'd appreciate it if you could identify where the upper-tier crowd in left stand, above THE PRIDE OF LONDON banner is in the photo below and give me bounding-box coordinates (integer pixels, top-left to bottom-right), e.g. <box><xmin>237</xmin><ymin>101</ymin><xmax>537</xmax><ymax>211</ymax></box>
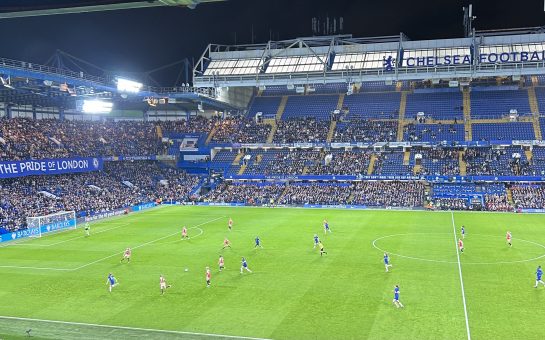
<box><xmin>0</xmin><ymin>118</ymin><xmax>166</xmax><ymax>160</ymax></box>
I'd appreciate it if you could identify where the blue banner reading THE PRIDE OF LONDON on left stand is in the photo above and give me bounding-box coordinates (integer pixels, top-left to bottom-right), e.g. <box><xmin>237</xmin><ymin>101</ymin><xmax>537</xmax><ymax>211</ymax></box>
<box><xmin>0</xmin><ymin>157</ymin><xmax>103</xmax><ymax>178</ymax></box>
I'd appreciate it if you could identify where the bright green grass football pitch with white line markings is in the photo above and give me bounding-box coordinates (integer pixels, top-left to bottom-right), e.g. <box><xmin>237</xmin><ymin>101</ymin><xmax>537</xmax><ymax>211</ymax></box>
<box><xmin>0</xmin><ymin>206</ymin><xmax>545</xmax><ymax>339</ymax></box>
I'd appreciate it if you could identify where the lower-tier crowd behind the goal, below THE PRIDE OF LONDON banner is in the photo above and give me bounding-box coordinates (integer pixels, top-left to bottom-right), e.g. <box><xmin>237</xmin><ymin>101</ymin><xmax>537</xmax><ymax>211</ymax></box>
<box><xmin>0</xmin><ymin>162</ymin><xmax>198</xmax><ymax>234</ymax></box>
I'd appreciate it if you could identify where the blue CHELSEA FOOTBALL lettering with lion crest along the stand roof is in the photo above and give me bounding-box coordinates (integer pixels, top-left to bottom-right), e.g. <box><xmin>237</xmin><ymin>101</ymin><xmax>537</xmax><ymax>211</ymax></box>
<box><xmin>383</xmin><ymin>51</ymin><xmax>545</xmax><ymax>71</ymax></box>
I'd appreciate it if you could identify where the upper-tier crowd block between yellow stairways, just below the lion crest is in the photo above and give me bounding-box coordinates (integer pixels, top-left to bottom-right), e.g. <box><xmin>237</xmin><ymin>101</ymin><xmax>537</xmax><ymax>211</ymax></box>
<box><xmin>332</xmin><ymin>120</ymin><xmax>398</xmax><ymax>143</ymax></box>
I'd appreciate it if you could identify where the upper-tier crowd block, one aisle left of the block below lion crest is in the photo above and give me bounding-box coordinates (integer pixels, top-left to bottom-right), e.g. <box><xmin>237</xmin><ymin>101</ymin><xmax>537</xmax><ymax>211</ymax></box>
<box><xmin>273</xmin><ymin>118</ymin><xmax>330</xmax><ymax>144</ymax></box>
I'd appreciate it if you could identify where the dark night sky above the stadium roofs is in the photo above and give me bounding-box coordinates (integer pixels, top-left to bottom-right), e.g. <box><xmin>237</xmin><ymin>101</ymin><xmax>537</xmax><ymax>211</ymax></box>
<box><xmin>0</xmin><ymin>0</ymin><xmax>545</xmax><ymax>85</ymax></box>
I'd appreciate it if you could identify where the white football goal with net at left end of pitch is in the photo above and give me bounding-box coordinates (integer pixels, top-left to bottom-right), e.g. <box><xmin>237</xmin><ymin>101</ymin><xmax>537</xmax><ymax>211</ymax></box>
<box><xmin>26</xmin><ymin>211</ymin><xmax>77</xmax><ymax>237</ymax></box>
